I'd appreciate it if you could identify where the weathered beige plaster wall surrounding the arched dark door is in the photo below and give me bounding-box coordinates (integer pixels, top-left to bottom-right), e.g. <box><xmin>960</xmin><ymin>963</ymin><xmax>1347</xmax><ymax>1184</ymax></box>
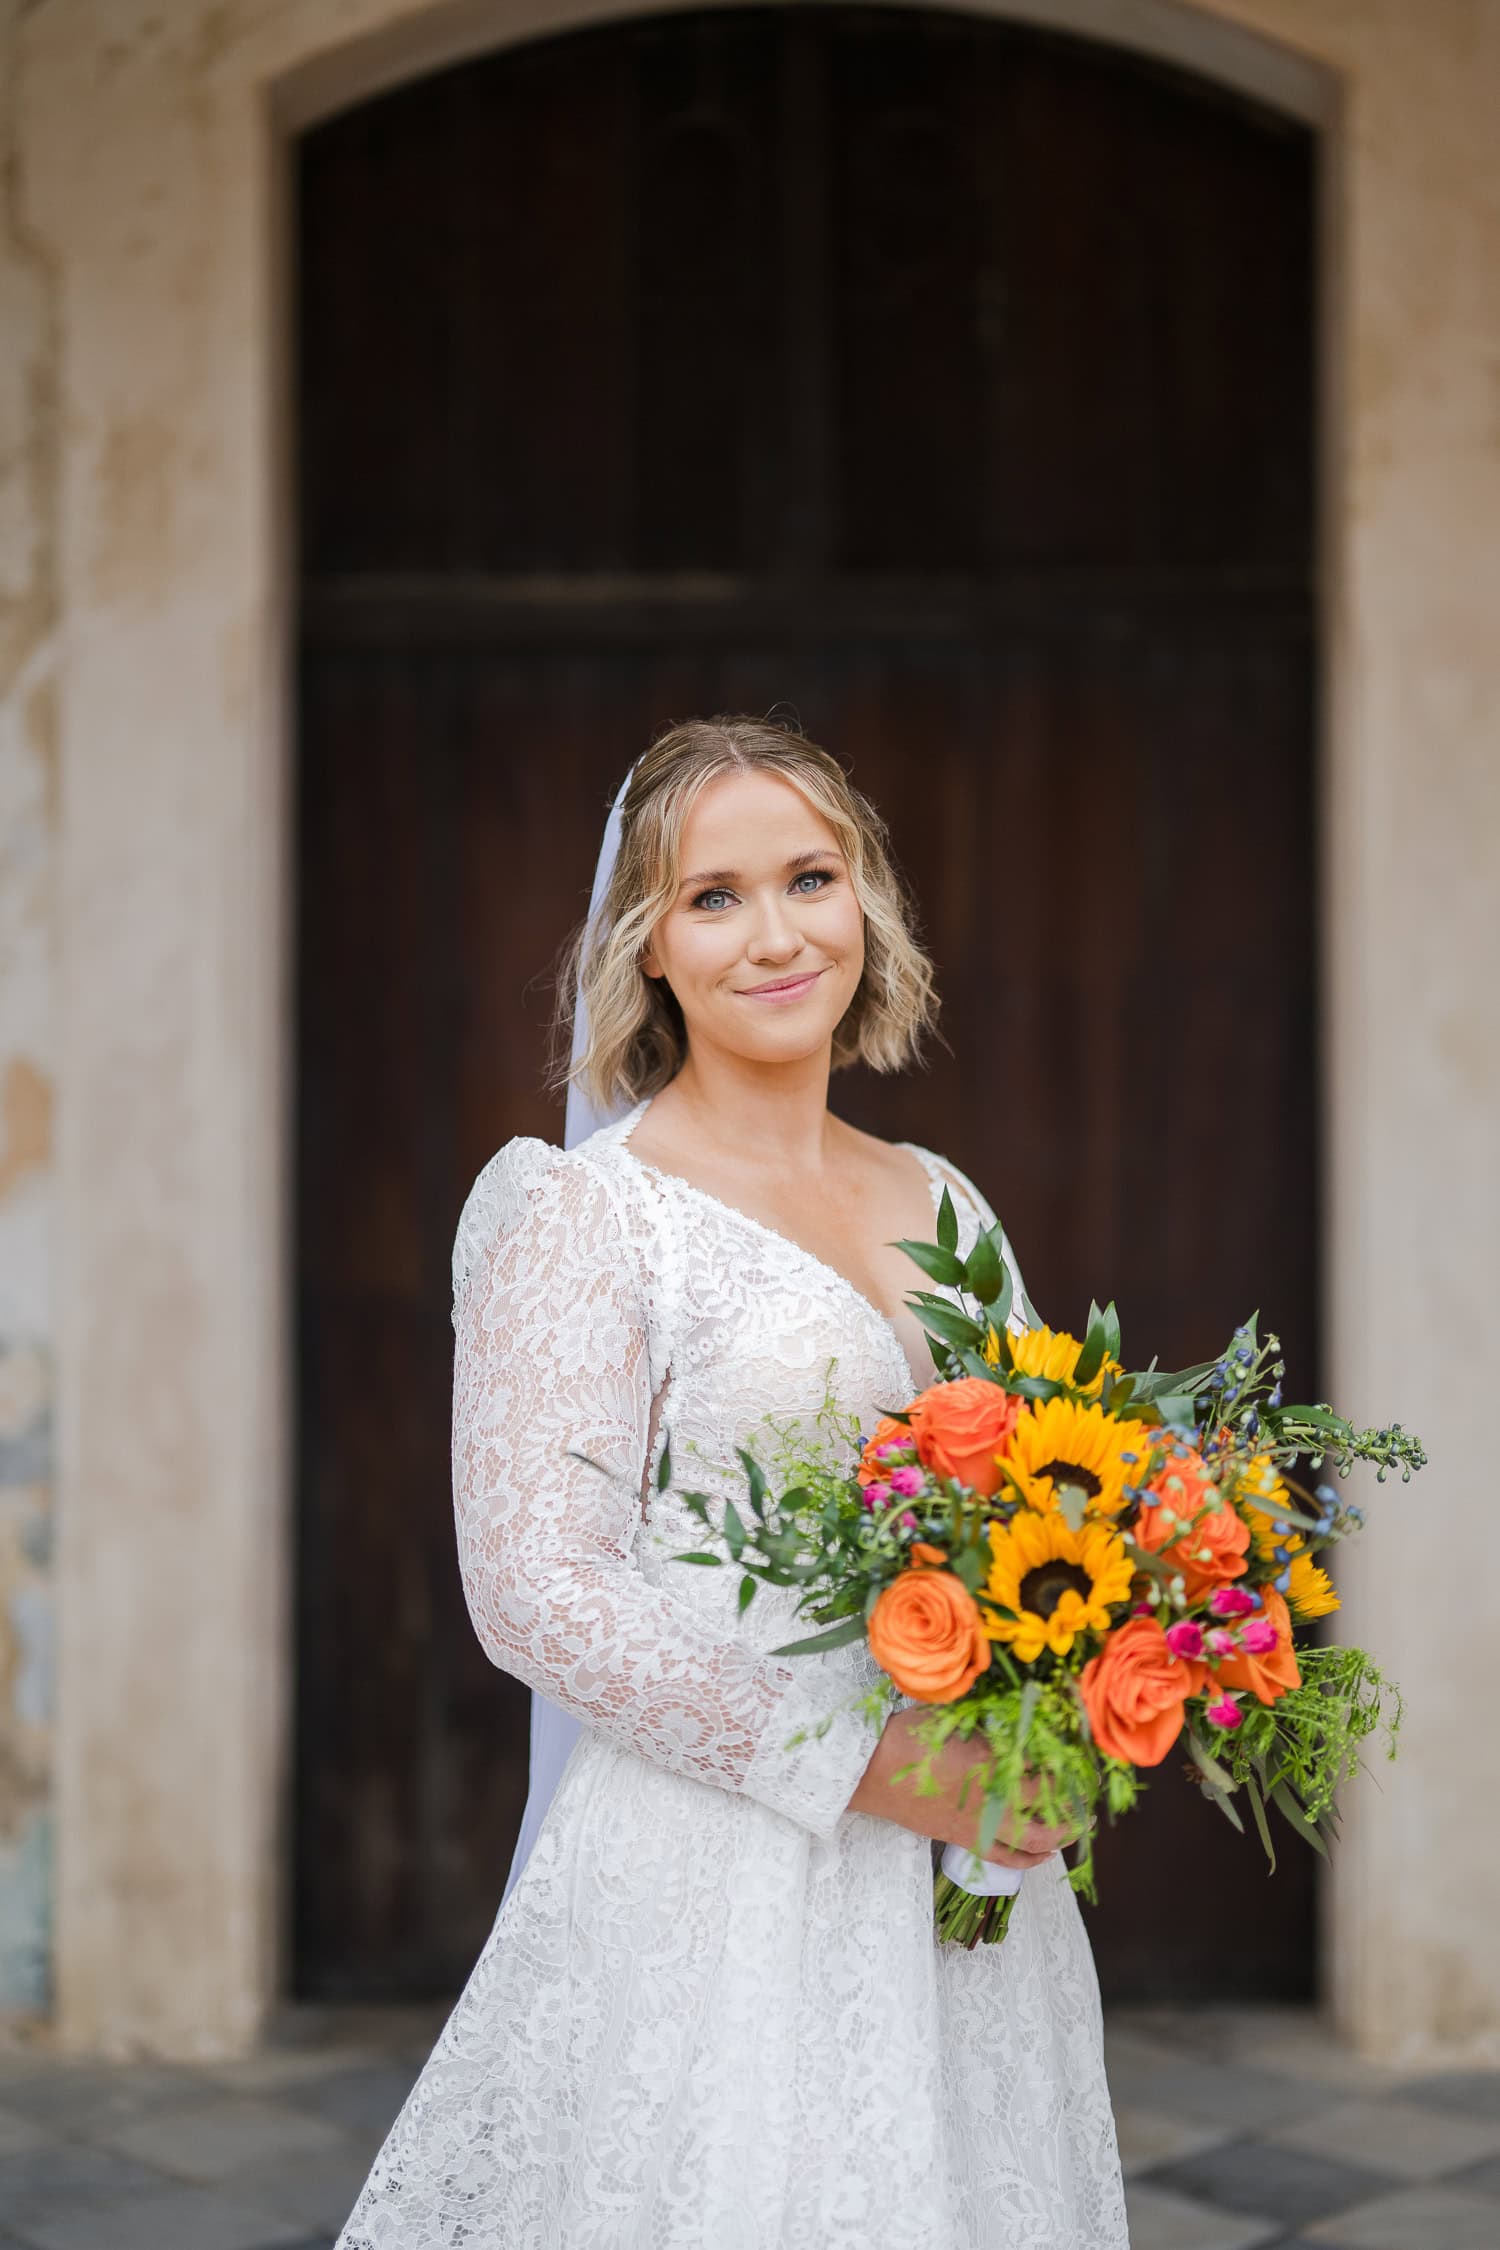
<box><xmin>0</xmin><ymin>0</ymin><xmax>1500</xmax><ymax>2059</ymax></box>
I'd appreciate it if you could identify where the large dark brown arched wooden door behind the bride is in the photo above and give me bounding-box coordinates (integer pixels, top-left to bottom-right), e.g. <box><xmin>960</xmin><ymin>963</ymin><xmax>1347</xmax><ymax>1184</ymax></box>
<box><xmin>297</xmin><ymin>7</ymin><xmax>1316</xmax><ymax>1996</ymax></box>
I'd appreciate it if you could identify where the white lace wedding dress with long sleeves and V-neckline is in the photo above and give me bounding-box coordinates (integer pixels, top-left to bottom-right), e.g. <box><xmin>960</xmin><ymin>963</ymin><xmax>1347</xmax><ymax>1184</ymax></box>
<box><xmin>337</xmin><ymin>1103</ymin><xmax>1127</xmax><ymax>2250</ymax></box>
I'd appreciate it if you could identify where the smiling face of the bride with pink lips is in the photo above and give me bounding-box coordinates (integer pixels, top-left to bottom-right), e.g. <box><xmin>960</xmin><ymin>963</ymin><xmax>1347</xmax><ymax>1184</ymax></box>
<box><xmin>641</xmin><ymin>772</ymin><xmax>864</xmax><ymax>1062</ymax></box>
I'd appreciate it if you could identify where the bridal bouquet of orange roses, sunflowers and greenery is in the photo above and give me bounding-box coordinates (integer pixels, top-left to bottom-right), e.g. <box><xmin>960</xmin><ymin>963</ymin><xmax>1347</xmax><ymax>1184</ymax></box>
<box><xmin>661</xmin><ymin>1193</ymin><xmax>1426</xmax><ymax>1946</ymax></box>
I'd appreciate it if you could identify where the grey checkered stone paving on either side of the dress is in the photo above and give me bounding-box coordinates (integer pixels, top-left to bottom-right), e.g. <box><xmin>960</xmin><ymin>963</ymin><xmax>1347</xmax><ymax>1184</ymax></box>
<box><xmin>0</xmin><ymin>2009</ymin><xmax>1500</xmax><ymax>2250</ymax></box>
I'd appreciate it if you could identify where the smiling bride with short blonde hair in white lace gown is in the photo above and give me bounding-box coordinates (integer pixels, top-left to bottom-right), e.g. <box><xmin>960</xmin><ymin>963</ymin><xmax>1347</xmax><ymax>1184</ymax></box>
<box><xmin>337</xmin><ymin>718</ymin><xmax>1127</xmax><ymax>2250</ymax></box>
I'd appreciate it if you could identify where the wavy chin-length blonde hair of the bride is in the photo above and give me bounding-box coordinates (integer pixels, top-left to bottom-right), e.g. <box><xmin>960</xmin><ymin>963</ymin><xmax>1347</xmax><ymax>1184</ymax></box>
<box><xmin>553</xmin><ymin>716</ymin><xmax>938</xmax><ymax>1107</ymax></box>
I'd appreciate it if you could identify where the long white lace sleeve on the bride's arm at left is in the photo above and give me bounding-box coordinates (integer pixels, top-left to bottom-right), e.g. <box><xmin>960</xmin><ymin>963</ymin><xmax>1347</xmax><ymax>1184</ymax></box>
<box><xmin>452</xmin><ymin>1141</ymin><xmax>877</xmax><ymax>1838</ymax></box>
